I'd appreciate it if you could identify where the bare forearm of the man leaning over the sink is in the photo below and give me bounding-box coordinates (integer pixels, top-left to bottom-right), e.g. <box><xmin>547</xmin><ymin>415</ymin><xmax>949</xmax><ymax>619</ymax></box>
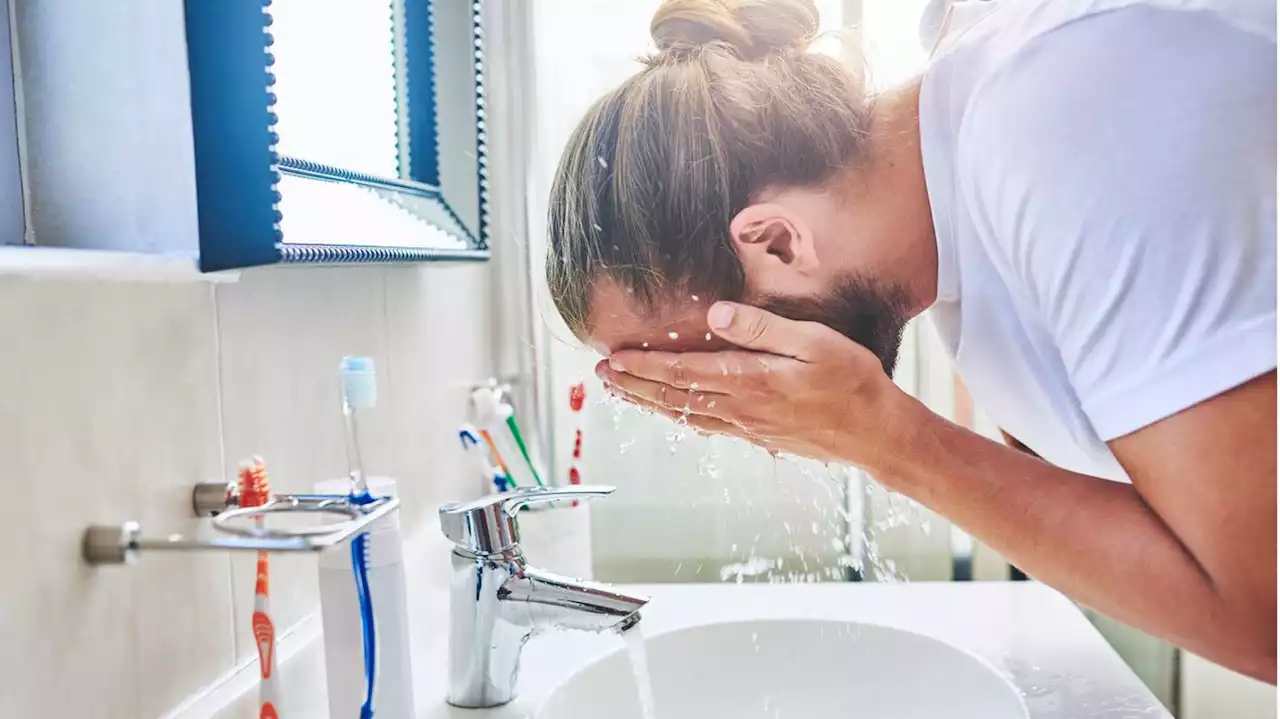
<box><xmin>873</xmin><ymin>404</ymin><xmax>1275</xmax><ymax>682</ymax></box>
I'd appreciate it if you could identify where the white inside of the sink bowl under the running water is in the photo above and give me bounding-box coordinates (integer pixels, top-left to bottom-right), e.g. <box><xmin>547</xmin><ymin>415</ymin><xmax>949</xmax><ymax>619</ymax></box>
<box><xmin>536</xmin><ymin>619</ymin><xmax>1028</xmax><ymax>719</ymax></box>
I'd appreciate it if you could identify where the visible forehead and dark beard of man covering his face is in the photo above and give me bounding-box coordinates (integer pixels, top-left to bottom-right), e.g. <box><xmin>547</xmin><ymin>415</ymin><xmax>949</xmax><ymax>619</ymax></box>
<box><xmin>589</xmin><ymin>278</ymin><xmax>910</xmax><ymax>376</ymax></box>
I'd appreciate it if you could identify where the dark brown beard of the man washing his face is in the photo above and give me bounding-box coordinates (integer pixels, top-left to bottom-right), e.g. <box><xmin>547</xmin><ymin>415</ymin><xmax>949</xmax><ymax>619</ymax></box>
<box><xmin>756</xmin><ymin>276</ymin><xmax>911</xmax><ymax>377</ymax></box>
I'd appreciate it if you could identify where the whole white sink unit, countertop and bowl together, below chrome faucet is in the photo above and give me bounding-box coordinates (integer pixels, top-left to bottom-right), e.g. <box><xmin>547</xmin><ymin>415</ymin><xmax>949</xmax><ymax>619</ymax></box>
<box><xmin>424</xmin><ymin>582</ymin><xmax>1172</xmax><ymax>719</ymax></box>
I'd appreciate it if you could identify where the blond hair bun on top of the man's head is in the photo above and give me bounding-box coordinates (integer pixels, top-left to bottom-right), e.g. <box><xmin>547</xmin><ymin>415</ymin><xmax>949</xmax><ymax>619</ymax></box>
<box><xmin>649</xmin><ymin>0</ymin><xmax>818</xmax><ymax>60</ymax></box>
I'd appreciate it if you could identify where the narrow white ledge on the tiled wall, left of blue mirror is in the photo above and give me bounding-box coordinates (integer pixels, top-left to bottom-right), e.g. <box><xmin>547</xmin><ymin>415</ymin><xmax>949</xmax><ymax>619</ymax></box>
<box><xmin>0</xmin><ymin>246</ymin><xmax>239</xmax><ymax>283</ymax></box>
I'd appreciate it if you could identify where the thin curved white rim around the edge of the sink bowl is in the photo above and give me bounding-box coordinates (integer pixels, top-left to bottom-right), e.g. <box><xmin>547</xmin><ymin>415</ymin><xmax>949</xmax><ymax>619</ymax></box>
<box><xmin>529</xmin><ymin>614</ymin><xmax>1033</xmax><ymax>719</ymax></box>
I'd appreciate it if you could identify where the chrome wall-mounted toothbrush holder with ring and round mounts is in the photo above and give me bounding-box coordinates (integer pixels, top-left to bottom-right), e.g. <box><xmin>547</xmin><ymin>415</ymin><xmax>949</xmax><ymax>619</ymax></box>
<box><xmin>82</xmin><ymin>482</ymin><xmax>399</xmax><ymax>564</ymax></box>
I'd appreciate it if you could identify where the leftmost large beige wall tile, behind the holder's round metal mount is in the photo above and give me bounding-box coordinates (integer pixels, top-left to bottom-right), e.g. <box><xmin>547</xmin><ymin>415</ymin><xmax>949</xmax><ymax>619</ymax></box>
<box><xmin>0</xmin><ymin>279</ymin><xmax>233</xmax><ymax>718</ymax></box>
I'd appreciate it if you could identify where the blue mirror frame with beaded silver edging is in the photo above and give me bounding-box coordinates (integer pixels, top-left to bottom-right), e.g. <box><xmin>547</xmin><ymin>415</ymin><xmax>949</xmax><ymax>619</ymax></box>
<box><xmin>183</xmin><ymin>0</ymin><xmax>489</xmax><ymax>273</ymax></box>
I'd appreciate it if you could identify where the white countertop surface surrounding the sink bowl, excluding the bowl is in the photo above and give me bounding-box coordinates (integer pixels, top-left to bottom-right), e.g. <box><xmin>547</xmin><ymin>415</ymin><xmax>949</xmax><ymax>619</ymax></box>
<box><xmin>415</xmin><ymin>582</ymin><xmax>1171</xmax><ymax>719</ymax></box>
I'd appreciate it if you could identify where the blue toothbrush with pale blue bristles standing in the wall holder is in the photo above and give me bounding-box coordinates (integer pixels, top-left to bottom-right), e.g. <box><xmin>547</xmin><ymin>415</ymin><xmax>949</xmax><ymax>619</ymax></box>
<box><xmin>339</xmin><ymin>357</ymin><xmax>378</xmax><ymax>719</ymax></box>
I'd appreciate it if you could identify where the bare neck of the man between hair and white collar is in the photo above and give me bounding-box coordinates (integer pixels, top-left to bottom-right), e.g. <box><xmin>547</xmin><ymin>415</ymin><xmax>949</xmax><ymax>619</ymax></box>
<box><xmin>860</xmin><ymin>79</ymin><xmax>938</xmax><ymax>315</ymax></box>
